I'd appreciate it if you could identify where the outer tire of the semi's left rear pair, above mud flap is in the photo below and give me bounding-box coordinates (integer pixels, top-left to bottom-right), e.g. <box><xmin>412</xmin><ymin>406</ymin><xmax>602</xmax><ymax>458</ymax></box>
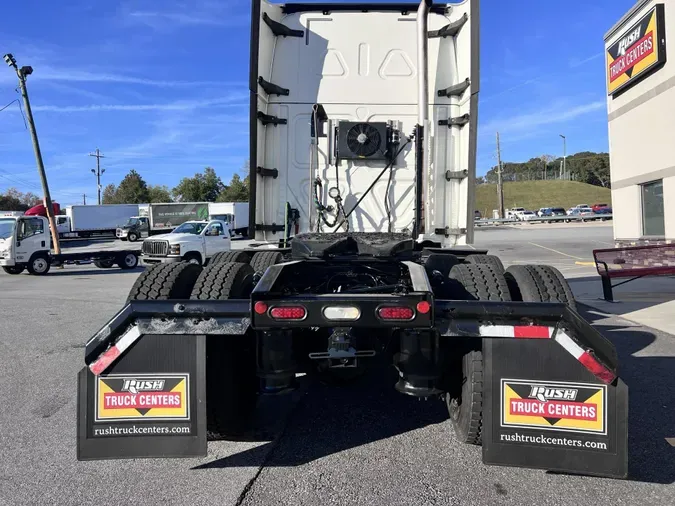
<box><xmin>127</xmin><ymin>262</ymin><xmax>202</xmax><ymax>301</ymax></box>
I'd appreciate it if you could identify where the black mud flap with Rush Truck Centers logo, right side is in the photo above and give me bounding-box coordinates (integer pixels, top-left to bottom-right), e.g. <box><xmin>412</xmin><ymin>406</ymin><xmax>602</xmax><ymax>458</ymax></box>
<box><xmin>483</xmin><ymin>338</ymin><xmax>628</xmax><ymax>478</ymax></box>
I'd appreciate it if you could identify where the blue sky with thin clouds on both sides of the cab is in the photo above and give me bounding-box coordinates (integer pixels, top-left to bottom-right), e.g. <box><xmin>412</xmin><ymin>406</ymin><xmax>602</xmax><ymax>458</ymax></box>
<box><xmin>0</xmin><ymin>0</ymin><xmax>634</xmax><ymax>205</ymax></box>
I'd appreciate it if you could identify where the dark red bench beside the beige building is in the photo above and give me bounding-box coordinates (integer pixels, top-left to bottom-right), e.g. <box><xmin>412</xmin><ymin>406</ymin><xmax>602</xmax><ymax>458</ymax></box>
<box><xmin>593</xmin><ymin>244</ymin><xmax>675</xmax><ymax>302</ymax></box>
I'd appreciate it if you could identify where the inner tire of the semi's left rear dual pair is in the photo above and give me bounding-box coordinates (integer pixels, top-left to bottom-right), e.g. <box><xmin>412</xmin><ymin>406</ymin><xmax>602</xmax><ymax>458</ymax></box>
<box><xmin>190</xmin><ymin>262</ymin><xmax>258</xmax><ymax>440</ymax></box>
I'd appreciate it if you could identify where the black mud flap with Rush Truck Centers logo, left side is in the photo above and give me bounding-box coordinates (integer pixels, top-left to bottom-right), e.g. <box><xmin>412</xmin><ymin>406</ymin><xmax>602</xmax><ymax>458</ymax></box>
<box><xmin>77</xmin><ymin>334</ymin><xmax>206</xmax><ymax>460</ymax></box>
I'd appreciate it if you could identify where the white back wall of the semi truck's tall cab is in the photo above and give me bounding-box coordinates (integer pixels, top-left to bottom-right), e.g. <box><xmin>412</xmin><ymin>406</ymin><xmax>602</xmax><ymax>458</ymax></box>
<box><xmin>249</xmin><ymin>0</ymin><xmax>479</xmax><ymax>246</ymax></box>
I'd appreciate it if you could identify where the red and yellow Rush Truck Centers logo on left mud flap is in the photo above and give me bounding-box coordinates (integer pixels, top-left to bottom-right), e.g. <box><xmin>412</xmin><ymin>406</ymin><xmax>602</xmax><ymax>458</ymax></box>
<box><xmin>96</xmin><ymin>374</ymin><xmax>190</xmax><ymax>422</ymax></box>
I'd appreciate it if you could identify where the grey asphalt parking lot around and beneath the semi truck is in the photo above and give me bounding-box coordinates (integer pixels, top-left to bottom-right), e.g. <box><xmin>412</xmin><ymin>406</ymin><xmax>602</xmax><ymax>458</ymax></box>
<box><xmin>0</xmin><ymin>224</ymin><xmax>675</xmax><ymax>506</ymax></box>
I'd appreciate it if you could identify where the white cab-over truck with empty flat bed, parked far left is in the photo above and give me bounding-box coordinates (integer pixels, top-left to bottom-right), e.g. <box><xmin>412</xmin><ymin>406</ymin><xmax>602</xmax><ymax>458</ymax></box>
<box><xmin>0</xmin><ymin>216</ymin><xmax>140</xmax><ymax>276</ymax></box>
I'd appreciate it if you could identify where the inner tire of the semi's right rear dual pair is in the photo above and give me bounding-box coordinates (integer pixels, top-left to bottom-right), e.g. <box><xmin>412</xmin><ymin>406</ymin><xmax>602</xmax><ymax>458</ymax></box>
<box><xmin>445</xmin><ymin>264</ymin><xmax>511</xmax><ymax>445</ymax></box>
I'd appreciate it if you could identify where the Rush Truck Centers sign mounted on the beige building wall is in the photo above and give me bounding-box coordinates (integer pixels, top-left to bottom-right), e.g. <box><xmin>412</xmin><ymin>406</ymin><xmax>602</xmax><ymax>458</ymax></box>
<box><xmin>607</xmin><ymin>4</ymin><xmax>666</xmax><ymax>95</ymax></box>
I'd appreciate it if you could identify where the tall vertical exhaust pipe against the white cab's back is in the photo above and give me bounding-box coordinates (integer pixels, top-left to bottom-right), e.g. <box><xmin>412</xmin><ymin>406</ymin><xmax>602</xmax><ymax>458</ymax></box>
<box><xmin>413</xmin><ymin>0</ymin><xmax>433</xmax><ymax>239</ymax></box>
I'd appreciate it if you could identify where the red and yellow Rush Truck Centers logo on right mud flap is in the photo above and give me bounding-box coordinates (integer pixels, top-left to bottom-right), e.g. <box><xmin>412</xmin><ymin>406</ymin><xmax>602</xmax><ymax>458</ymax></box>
<box><xmin>501</xmin><ymin>379</ymin><xmax>607</xmax><ymax>434</ymax></box>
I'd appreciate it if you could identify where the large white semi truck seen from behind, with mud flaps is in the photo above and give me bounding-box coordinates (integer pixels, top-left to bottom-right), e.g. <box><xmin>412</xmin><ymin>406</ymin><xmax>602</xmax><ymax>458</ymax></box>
<box><xmin>78</xmin><ymin>0</ymin><xmax>628</xmax><ymax>479</ymax></box>
